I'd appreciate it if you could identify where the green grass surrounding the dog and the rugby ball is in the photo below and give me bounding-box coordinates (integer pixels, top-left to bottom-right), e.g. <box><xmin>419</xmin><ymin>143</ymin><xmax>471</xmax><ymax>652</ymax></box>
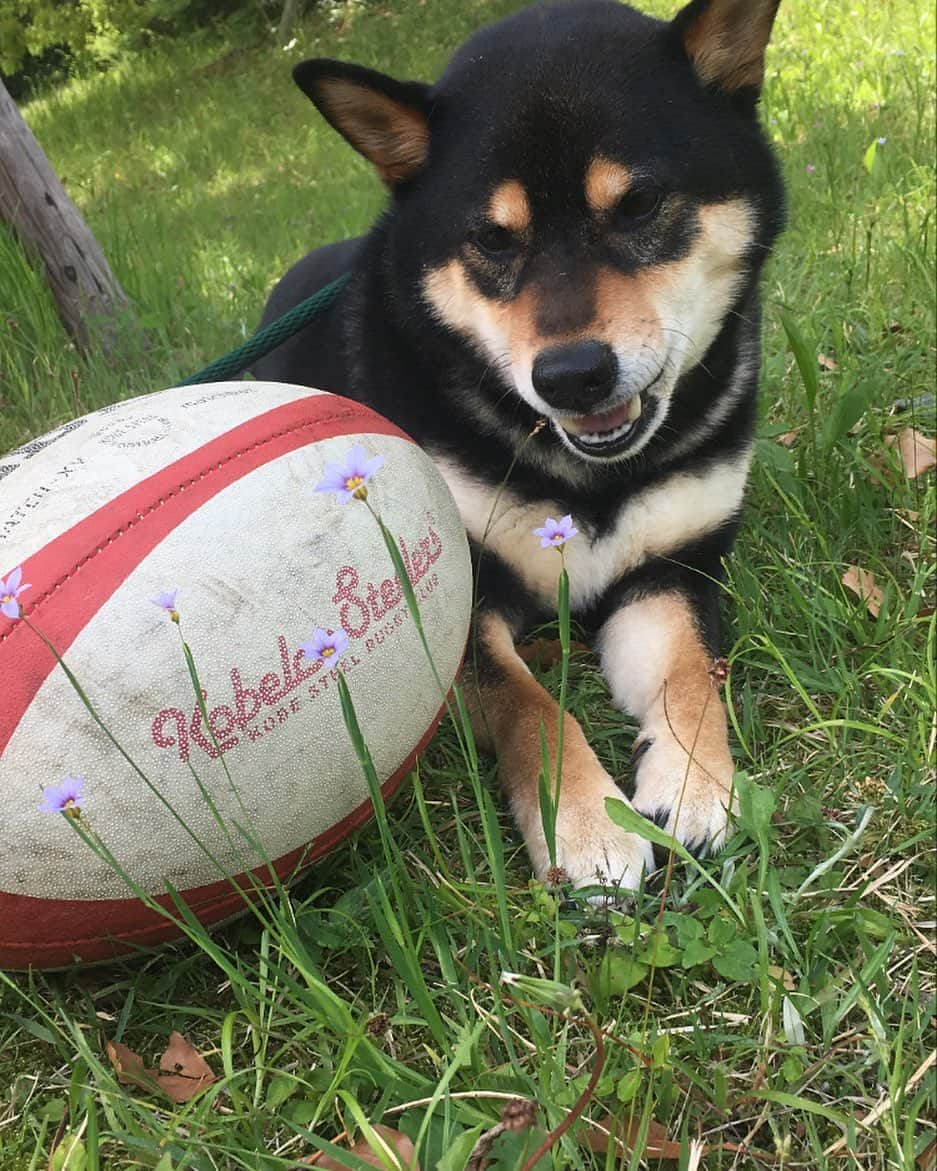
<box><xmin>0</xmin><ymin>0</ymin><xmax>937</xmax><ymax>1171</ymax></box>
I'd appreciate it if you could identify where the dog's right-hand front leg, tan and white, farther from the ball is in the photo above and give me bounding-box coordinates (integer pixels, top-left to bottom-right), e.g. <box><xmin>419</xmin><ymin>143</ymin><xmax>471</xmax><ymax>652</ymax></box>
<box><xmin>599</xmin><ymin>591</ymin><xmax>733</xmax><ymax>852</ymax></box>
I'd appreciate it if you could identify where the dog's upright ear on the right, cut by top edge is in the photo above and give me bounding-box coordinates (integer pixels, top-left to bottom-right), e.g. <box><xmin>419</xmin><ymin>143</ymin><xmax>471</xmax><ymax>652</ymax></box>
<box><xmin>671</xmin><ymin>0</ymin><xmax>780</xmax><ymax>98</ymax></box>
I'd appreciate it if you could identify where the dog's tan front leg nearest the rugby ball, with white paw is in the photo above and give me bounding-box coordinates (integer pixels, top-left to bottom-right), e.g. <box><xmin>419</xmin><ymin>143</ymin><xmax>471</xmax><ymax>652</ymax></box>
<box><xmin>464</xmin><ymin>612</ymin><xmax>654</xmax><ymax>890</ymax></box>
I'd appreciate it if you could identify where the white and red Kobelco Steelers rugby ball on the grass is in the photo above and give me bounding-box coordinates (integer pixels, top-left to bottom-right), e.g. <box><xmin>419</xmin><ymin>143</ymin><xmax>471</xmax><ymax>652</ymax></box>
<box><xmin>0</xmin><ymin>382</ymin><xmax>472</xmax><ymax>968</ymax></box>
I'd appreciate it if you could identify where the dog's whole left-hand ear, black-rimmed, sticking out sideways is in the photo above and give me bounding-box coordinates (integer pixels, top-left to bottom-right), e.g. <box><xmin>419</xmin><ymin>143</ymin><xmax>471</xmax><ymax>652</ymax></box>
<box><xmin>293</xmin><ymin>57</ymin><xmax>430</xmax><ymax>186</ymax></box>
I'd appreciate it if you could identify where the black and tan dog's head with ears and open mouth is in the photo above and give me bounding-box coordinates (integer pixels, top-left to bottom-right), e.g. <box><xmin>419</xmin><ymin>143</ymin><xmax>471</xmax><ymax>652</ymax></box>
<box><xmin>294</xmin><ymin>0</ymin><xmax>782</xmax><ymax>461</ymax></box>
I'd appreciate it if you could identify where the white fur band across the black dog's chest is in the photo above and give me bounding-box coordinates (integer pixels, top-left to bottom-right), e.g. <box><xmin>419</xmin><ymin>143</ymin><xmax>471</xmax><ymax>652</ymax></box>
<box><xmin>436</xmin><ymin>452</ymin><xmax>751</xmax><ymax>611</ymax></box>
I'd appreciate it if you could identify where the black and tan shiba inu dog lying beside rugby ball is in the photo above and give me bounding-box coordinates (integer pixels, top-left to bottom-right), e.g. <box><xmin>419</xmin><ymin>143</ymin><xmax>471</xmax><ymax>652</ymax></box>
<box><xmin>254</xmin><ymin>0</ymin><xmax>784</xmax><ymax>886</ymax></box>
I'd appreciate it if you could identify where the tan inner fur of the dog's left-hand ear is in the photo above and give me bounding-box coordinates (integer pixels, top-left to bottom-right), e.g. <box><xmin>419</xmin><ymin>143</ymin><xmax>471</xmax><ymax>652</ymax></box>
<box><xmin>320</xmin><ymin>78</ymin><xmax>430</xmax><ymax>184</ymax></box>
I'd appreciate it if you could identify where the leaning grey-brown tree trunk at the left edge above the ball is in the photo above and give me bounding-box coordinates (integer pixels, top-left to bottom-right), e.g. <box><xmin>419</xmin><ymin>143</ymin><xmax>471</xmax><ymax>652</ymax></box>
<box><xmin>0</xmin><ymin>81</ymin><xmax>132</xmax><ymax>350</ymax></box>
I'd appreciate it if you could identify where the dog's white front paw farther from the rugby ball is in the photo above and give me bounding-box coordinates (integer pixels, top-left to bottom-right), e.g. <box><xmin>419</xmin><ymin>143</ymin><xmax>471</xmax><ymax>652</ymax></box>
<box><xmin>632</xmin><ymin>735</ymin><xmax>738</xmax><ymax>857</ymax></box>
